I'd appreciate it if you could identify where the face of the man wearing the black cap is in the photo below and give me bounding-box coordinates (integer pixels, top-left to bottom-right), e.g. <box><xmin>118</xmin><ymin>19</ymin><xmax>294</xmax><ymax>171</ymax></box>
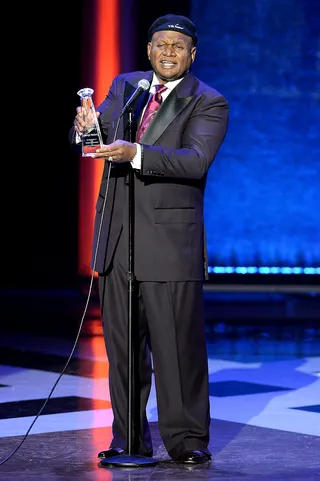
<box><xmin>148</xmin><ymin>30</ymin><xmax>196</xmax><ymax>83</ymax></box>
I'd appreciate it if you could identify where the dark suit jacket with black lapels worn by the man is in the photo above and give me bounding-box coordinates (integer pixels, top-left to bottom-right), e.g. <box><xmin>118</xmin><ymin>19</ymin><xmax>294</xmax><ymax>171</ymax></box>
<box><xmin>74</xmin><ymin>71</ymin><xmax>229</xmax><ymax>281</ymax></box>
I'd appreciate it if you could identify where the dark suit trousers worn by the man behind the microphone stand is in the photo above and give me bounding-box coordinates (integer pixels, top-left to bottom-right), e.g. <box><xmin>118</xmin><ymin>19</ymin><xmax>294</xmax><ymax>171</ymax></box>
<box><xmin>99</xmin><ymin>231</ymin><xmax>210</xmax><ymax>459</ymax></box>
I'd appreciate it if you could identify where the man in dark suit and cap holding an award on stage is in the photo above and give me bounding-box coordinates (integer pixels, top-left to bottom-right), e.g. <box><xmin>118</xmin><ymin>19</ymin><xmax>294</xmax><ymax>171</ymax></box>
<box><xmin>71</xmin><ymin>14</ymin><xmax>229</xmax><ymax>464</ymax></box>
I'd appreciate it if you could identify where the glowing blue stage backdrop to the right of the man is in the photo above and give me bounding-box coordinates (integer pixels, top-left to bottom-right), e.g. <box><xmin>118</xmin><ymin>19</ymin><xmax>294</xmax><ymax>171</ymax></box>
<box><xmin>190</xmin><ymin>0</ymin><xmax>320</xmax><ymax>274</ymax></box>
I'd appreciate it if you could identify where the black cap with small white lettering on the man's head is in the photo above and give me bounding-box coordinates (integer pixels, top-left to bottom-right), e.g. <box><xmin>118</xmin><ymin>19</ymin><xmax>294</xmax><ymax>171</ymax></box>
<box><xmin>148</xmin><ymin>13</ymin><xmax>198</xmax><ymax>45</ymax></box>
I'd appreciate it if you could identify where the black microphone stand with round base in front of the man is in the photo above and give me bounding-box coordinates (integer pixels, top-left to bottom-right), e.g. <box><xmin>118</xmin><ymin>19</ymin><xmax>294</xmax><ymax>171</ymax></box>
<box><xmin>100</xmin><ymin>108</ymin><xmax>158</xmax><ymax>468</ymax></box>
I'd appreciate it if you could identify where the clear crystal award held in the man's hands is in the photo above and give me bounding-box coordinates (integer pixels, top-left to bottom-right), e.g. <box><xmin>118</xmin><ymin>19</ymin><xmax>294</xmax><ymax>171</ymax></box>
<box><xmin>77</xmin><ymin>87</ymin><xmax>103</xmax><ymax>157</ymax></box>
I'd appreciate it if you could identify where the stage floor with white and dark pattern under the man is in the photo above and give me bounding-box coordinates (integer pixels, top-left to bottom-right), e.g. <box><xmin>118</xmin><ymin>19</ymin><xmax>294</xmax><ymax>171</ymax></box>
<box><xmin>0</xmin><ymin>288</ymin><xmax>320</xmax><ymax>481</ymax></box>
